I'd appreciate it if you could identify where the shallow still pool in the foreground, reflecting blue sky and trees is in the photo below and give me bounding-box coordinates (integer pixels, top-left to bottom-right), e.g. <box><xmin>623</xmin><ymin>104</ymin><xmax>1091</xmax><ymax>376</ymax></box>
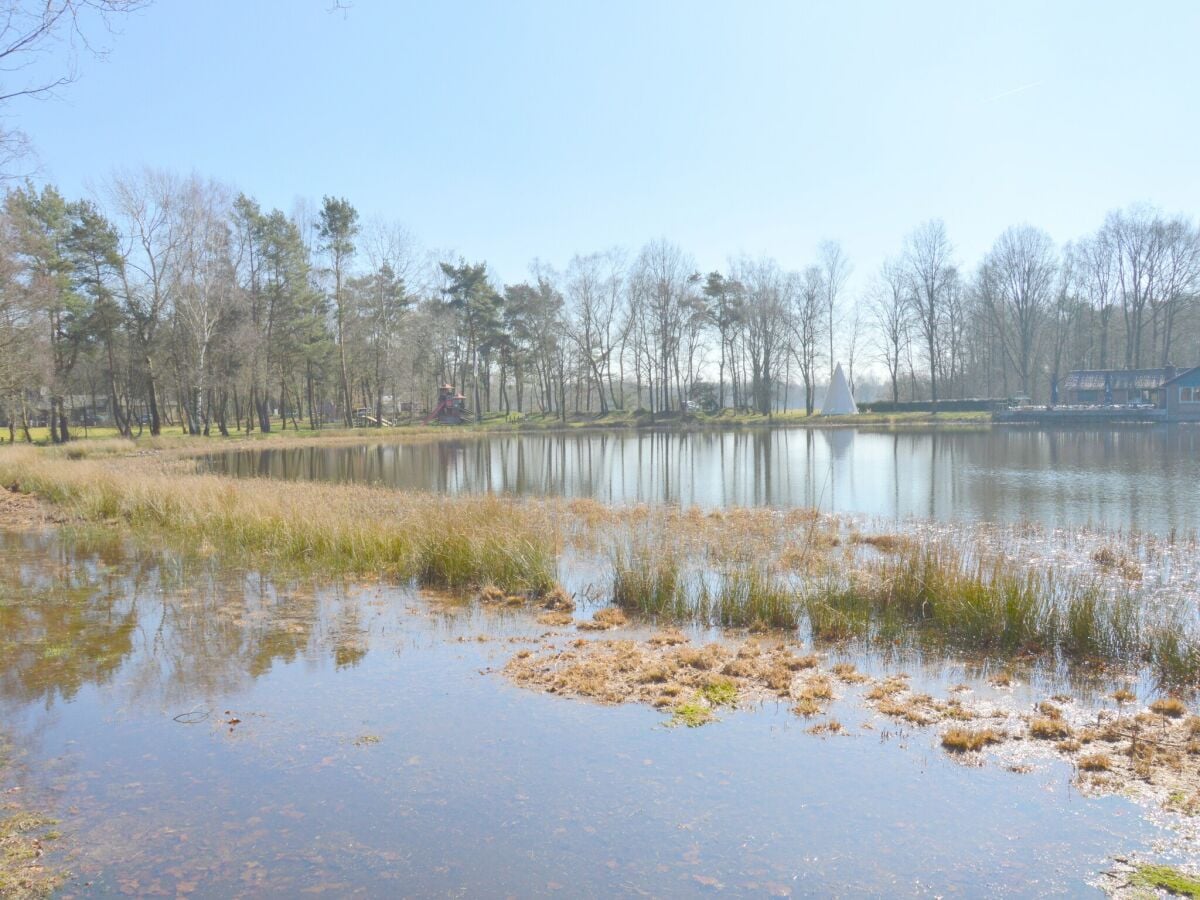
<box><xmin>0</xmin><ymin>535</ymin><xmax>1180</xmax><ymax>896</ymax></box>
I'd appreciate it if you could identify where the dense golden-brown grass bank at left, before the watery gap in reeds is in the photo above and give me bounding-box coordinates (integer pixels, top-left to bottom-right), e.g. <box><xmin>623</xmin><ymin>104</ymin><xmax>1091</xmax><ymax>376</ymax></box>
<box><xmin>0</xmin><ymin>448</ymin><xmax>560</xmax><ymax>596</ymax></box>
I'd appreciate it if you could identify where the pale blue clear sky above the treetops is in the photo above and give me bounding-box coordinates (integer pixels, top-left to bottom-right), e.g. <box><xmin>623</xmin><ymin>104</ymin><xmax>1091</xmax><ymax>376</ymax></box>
<box><xmin>14</xmin><ymin>0</ymin><xmax>1200</xmax><ymax>287</ymax></box>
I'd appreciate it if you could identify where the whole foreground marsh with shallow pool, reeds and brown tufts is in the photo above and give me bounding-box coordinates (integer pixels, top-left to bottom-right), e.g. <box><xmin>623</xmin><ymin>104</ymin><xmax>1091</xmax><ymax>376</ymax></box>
<box><xmin>0</xmin><ymin>432</ymin><xmax>1200</xmax><ymax>895</ymax></box>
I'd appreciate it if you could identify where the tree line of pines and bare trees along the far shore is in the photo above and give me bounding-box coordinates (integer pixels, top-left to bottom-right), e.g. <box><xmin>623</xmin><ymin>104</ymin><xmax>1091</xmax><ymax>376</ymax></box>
<box><xmin>0</xmin><ymin>168</ymin><xmax>1200</xmax><ymax>442</ymax></box>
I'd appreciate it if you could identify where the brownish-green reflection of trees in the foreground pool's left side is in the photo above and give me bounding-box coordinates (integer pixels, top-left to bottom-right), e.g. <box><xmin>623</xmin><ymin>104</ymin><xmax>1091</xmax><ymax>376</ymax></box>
<box><xmin>0</xmin><ymin>535</ymin><xmax>368</xmax><ymax>720</ymax></box>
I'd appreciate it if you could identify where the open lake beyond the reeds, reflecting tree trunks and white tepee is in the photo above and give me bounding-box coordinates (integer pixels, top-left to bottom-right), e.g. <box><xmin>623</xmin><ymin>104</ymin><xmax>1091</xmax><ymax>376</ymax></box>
<box><xmin>208</xmin><ymin>425</ymin><xmax>1200</xmax><ymax>535</ymax></box>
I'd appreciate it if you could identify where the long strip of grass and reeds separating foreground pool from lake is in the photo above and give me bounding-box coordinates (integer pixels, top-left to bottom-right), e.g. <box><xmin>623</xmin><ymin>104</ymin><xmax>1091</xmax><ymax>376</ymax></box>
<box><xmin>0</xmin><ymin>445</ymin><xmax>1200</xmax><ymax>686</ymax></box>
